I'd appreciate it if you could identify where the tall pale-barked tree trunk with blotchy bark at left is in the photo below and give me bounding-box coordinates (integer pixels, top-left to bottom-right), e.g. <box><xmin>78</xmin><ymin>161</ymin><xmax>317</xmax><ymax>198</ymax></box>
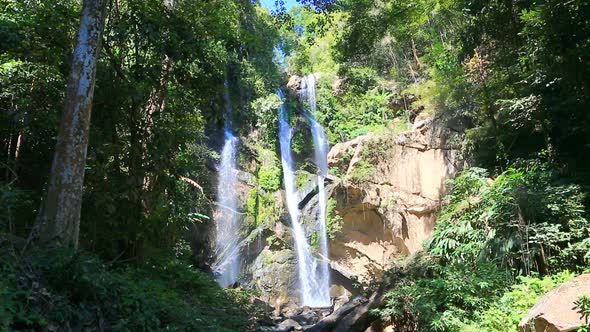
<box><xmin>32</xmin><ymin>0</ymin><xmax>107</xmax><ymax>248</ymax></box>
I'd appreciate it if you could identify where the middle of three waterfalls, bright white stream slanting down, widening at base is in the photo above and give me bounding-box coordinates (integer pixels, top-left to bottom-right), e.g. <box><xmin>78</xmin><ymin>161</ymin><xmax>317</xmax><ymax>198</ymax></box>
<box><xmin>277</xmin><ymin>90</ymin><xmax>330</xmax><ymax>307</ymax></box>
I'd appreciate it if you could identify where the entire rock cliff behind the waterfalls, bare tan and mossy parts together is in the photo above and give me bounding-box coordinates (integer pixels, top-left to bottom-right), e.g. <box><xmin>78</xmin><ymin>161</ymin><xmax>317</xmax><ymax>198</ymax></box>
<box><xmin>236</xmin><ymin>116</ymin><xmax>462</xmax><ymax>305</ymax></box>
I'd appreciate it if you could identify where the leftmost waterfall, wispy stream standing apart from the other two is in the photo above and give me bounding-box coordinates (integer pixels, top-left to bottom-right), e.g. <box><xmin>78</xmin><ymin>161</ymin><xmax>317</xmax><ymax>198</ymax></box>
<box><xmin>213</xmin><ymin>81</ymin><xmax>241</xmax><ymax>287</ymax></box>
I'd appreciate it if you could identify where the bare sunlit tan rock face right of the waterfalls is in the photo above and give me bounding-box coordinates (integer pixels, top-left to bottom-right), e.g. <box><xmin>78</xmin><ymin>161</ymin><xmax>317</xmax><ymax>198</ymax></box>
<box><xmin>328</xmin><ymin>120</ymin><xmax>462</xmax><ymax>283</ymax></box>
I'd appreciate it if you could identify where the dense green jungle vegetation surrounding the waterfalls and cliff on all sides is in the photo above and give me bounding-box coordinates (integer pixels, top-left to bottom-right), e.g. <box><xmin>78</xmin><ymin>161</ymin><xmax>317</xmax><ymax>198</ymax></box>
<box><xmin>0</xmin><ymin>0</ymin><xmax>590</xmax><ymax>331</ymax></box>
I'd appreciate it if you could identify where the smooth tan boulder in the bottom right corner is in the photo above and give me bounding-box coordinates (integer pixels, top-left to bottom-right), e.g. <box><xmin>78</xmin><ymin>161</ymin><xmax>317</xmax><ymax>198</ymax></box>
<box><xmin>518</xmin><ymin>274</ymin><xmax>590</xmax><ymax>332</ymax></box>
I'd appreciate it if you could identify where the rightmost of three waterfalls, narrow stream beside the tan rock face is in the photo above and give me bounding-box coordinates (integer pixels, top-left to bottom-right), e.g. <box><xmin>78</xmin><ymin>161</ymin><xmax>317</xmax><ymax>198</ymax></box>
<box><xmin>303</xmin><ymin>74</ymin><xmax>330</xmax><ymax>304</ymax></box>
